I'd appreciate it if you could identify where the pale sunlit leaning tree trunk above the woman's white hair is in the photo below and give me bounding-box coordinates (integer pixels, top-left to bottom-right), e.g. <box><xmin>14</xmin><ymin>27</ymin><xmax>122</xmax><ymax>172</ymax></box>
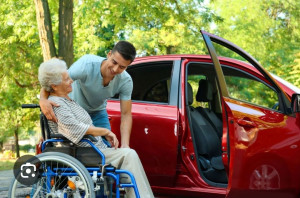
<box><xmin>34</xmin><ymin>0</ymin><xmax>56</xmax><ymax>61</ymax></box>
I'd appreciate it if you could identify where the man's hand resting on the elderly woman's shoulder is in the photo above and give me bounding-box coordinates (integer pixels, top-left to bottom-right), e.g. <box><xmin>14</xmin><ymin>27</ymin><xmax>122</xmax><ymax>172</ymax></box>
<box><xmin>39</xmin><ymin>88</ymin><xmax>59</xmax><ymax>122</ymax></box>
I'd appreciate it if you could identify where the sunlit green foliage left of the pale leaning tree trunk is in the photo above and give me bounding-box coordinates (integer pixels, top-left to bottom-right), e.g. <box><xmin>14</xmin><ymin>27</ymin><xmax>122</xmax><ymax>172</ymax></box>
<box><xmin>0</xmin><ymin>1</ymin><xmax>42</xmax><ymax>156</ymax></box>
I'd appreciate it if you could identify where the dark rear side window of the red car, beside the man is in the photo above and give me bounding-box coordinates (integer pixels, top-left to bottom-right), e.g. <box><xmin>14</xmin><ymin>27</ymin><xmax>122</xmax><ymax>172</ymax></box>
<box><xmin>127</xmin><ymin>61</ymin><xmax>173</xmax><ymax>103</ymax></box>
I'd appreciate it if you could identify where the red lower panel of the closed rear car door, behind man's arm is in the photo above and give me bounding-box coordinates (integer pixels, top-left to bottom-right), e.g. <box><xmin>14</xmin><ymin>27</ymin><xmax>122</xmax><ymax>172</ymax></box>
<box><xmin>107</xmin><ymin>101</ymin><xmax>178</xmax><ymax>186</ymax></box>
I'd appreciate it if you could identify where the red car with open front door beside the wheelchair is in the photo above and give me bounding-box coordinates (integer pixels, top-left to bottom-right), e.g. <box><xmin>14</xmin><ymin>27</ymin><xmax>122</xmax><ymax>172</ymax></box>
<box><xmin>107</xmin><ymin>31</ymin><xmax>300</xmax><ymax>198</ymax></box>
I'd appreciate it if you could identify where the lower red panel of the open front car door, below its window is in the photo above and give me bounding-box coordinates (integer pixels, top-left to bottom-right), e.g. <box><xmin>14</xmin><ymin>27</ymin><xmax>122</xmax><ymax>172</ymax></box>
<box><xmin>224</xmin><ymin>98</ymin><xmax>300</xmax><ymax>197</ymax></box>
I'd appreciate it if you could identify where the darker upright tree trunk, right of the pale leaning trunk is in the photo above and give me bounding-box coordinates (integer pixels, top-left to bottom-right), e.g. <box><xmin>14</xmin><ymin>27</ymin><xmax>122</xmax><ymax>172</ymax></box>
<box><xmin>58</xmin><ymin>0</ymin><xmax>74</xmax><ymax>66</ymax></box>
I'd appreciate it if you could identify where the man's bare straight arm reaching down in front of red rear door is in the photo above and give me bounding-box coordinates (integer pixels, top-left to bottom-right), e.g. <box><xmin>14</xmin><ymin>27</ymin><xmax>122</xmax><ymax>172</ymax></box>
<box><xmin>120</xmin><ymin>100</ymin><xmax>132</xmax><ymax>148</ymax></box>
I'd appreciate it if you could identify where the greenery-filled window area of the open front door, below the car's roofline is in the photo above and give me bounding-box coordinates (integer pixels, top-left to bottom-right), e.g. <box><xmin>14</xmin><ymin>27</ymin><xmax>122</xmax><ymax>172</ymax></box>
<box><xmin>223</xmin><ymin>68</ymin><xmax>279</xmax><ymax>109</ymax></box>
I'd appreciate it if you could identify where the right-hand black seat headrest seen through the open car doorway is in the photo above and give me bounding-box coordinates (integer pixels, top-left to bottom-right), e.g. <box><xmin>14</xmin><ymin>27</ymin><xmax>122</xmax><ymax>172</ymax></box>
<box><xmin>196</xmin><ymin>79</ymin><xmax>213</xmax><ymax>102</ymax></box>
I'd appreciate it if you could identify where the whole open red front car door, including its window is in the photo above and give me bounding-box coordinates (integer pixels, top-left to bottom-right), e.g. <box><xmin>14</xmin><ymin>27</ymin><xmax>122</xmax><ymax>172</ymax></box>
<box><xmin>201</xmin><ymin>31</ymin><xmax>299</xmax><ymax>197</ymax></box>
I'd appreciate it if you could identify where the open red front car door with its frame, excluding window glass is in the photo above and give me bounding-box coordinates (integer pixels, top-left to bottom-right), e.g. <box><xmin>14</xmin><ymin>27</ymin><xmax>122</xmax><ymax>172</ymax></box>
<box><xmin>202</xmin><ymin>31</ymin><xmax>300</xmax><ymax>197</ymax></box>
